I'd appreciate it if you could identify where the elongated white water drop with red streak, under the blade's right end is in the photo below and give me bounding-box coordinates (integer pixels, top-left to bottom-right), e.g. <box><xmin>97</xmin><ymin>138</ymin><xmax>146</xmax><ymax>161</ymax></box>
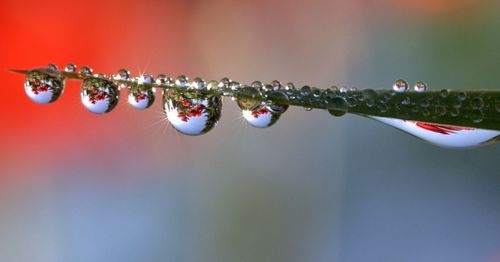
<box><xmin>371</xmin><ymin>116</ymin><xmax>500</xmax><ymax>149</ymax></box>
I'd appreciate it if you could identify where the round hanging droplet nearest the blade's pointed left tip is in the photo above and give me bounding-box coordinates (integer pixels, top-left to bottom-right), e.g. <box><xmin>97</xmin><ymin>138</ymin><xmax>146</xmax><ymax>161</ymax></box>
<box><xmin>24</xmin><ymin>69</ymin><xmax>65</xmax><ymax>104</ymax></box>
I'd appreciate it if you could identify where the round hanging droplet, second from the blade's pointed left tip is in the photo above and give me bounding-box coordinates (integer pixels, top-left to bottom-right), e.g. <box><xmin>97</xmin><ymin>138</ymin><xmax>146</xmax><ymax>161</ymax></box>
<box><xmin>80</xmin><ymin>77</ymin><xmax>120</xmax><ymax>114</ymax></box>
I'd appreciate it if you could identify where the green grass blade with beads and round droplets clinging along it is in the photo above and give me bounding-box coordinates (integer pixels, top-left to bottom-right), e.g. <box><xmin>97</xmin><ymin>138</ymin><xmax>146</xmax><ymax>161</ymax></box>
<box><xmin>18</xmin><ymin>64</ymin><xmax>500</xmax><ymax>135</ymax></box>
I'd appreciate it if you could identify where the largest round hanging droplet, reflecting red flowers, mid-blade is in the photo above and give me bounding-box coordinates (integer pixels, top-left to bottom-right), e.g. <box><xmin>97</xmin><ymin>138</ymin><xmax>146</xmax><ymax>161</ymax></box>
<box><xmin>163</xmin><ymin>90</ymin><xmax>222</xmax><ymax>136</ymax></box>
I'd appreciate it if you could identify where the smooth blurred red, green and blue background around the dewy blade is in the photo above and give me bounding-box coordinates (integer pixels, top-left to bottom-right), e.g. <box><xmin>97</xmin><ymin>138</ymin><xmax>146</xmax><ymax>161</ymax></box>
<box><xmin>0</xmin><ymin>0</ymin><xmax>500</xmax><ymax>262</ymax></box>
